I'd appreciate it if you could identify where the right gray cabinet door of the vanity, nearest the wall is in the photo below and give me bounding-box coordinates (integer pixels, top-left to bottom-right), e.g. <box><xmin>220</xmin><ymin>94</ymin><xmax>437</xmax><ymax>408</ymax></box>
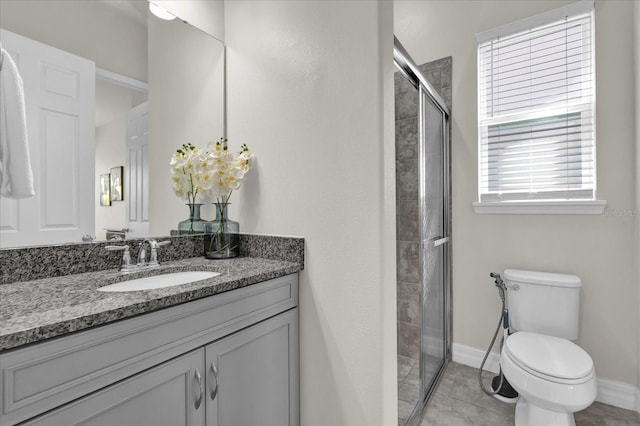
<box><xmin>206</xmin><ymin>308</ymin><xmax>299</xmax><ymax>426</ymax></box>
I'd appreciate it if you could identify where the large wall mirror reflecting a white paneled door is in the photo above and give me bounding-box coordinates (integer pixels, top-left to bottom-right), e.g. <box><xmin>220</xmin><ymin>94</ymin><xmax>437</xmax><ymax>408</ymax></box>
<box><xmin>0</xmin><ymin>0</ymin><xmax>225</xmax><ymax>248</ymax></box>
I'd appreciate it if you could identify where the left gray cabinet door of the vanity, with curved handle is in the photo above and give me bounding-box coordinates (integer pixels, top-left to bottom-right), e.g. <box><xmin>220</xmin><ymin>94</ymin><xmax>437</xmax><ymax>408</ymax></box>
<box><xmin>25</xmin><ymin>349</ymin><xmax>205</xmax><ymax>426</ymax></box>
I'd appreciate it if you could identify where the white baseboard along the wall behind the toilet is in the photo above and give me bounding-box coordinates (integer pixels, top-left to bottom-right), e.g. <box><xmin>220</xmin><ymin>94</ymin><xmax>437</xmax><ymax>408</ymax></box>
<box><xmin>451</xmin><ymin>343</ymin><xmax>640</xmax><ymax>413</ymax></box>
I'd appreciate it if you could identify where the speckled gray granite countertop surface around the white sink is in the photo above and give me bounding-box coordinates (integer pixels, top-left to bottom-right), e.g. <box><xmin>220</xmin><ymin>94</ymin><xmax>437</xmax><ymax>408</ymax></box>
<box><xmin>0</xmin><ymin>257</ymin><xmax>301</xmax><ymax>352</ymax></box>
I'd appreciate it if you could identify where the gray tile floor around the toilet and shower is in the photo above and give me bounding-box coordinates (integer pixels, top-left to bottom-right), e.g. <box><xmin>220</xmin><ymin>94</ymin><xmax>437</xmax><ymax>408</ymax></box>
<box><xmin>398</xmin><ymin>362</ymin><xmax>640</xmax><ymax>426</ymax></box>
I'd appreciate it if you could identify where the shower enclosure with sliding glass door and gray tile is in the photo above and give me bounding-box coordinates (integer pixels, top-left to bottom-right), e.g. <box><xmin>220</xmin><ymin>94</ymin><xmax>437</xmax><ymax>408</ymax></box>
<box><xmin>394</xmin><ymin>39</ymin><xmax>451</xmax><ymax>425</ymax></box>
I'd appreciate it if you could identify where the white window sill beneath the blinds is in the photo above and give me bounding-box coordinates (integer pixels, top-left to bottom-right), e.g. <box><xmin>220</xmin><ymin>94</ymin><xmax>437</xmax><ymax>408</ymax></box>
<box><xmin>473</xmin><ymin>200</ymin><xmax>607</xmax><ymax>214</ymax></box>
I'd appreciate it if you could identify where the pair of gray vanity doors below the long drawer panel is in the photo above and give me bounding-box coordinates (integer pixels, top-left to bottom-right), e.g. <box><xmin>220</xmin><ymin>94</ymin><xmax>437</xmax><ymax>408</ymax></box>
<box><xmin>25</xmin><ymin>309</ymin><xmax>298</xmax><ymax>426</ymax></box>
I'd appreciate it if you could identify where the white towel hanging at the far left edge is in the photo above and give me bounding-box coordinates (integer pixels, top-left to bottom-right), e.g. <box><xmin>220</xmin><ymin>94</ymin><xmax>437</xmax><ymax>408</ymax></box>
<box><xmin>0</xmin><ymin>46</ymin><xmax>35</xmax><ymax>198</ymax></box>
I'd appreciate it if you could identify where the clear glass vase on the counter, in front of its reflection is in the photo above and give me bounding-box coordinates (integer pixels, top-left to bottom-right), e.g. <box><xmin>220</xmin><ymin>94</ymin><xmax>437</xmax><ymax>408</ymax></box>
<box><xmin>204</xmin><ymin>203</ymin><xmax>240</xmax><ymax>259</ymax></box>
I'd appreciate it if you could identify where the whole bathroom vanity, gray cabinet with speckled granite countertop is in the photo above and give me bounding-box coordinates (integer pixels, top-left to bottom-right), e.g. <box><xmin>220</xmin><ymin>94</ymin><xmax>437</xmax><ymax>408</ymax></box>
<box><xmin>0</xmin><ymin>238</ymin><xmax>301</xmax><ymax>426</ymax></box>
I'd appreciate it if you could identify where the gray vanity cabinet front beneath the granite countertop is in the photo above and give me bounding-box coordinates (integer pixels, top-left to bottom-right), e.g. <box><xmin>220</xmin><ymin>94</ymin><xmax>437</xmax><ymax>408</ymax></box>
<box><xmin>0</xmin><ymin>274</ymin><xmax>299</xmax><ymax>426</ymax></box>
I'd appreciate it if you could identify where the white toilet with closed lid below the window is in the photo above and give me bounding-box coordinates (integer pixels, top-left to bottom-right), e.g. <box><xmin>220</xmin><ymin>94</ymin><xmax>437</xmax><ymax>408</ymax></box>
<box><xmin>500</xmin><ymin>269</ymin><xmax>597</xmax><ymax>426</ymax></box>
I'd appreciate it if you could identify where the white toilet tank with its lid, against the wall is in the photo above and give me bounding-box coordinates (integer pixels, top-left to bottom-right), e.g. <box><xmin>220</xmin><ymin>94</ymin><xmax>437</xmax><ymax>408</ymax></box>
<box><xmin>504</xmin><ymin>269</ymin><xmax>582</xmax><ymax>340</ymax></box>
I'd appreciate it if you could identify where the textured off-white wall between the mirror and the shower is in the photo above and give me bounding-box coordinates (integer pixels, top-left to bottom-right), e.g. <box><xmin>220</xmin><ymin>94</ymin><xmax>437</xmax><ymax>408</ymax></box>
<box><xmin>225</xmin><ymin>1</ymin><xmax>397</xmax><ymax>426</ymax></box>
